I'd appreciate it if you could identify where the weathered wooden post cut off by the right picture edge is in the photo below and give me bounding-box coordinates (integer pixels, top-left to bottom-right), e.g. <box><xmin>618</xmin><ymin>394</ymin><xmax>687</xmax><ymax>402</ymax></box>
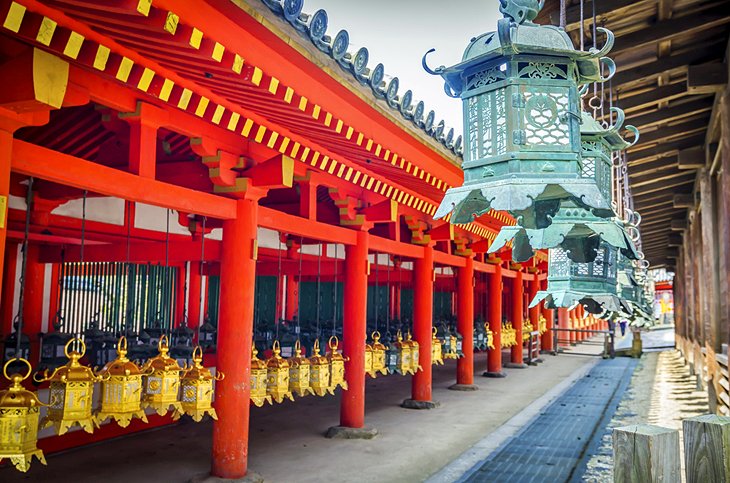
<box><xmin>682</xmin><ymin>414</ymin><xmax>730</xmax><ymax>483</ymax></box>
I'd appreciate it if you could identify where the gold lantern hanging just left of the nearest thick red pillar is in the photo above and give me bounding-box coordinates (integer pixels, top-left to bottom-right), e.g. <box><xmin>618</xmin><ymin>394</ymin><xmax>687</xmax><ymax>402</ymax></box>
<box><xmin>174</xmin><ymin>346</ymin><xmax>225</xmax><ymax>423</ymax></box>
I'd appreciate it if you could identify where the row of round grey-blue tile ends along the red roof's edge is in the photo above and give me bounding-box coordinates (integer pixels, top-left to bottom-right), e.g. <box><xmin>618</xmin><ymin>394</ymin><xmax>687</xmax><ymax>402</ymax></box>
<box><xmin>261</xmin><ymin>0</ymin><xmax>458</xmax><ymax>156</ymax></box>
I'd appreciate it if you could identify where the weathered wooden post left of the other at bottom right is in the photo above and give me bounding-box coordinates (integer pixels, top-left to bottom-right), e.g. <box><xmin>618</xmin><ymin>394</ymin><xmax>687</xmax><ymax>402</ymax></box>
<box><xmin>613</xmin><ymin>424</ymin><xmax>682</xmax><ymax>483</ymax></box>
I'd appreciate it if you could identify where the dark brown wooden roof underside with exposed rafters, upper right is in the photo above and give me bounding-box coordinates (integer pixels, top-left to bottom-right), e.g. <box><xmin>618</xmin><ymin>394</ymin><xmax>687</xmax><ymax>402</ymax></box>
<box><xmin>536</xmin><ymin>0</ymin><xmax>730</xmax><ymax>267</ymax></box>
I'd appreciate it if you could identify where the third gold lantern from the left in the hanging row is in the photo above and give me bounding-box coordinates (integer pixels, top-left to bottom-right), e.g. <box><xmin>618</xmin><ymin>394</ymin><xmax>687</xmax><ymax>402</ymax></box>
<box><xmin>95</xmin><ymin>336</ymin><xmax>147</xmax><ymax>428</ymax></box>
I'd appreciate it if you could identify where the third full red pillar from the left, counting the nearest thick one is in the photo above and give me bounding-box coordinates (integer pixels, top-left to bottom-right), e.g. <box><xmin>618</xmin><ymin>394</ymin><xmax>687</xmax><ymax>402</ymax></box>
<box><xmin>402</xmin><ymin>245</ymin><xmax>438</xmax><ymax>409</ymax></box>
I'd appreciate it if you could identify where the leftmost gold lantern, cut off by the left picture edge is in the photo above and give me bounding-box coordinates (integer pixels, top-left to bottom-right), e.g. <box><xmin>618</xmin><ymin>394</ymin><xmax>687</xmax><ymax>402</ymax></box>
<box><xmin>0</xmin><ymin>359</ymin><xmax>46</xmax><ymax>473</ymax></box>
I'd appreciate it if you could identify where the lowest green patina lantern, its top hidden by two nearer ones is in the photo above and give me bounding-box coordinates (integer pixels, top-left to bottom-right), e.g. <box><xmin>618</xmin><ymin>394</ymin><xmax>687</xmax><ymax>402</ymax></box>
<box><xmin>530</xmin><ymin>243</ymin><xmax>631</xmax><ymax>314</ymax></box>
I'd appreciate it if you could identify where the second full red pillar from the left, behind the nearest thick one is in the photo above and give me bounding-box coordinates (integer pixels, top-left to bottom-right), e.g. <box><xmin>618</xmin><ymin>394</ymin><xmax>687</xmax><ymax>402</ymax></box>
<box><xmin>340</xmin><ymin>231</ymin><xmax>369</xmax><ymax>428</ymax></box>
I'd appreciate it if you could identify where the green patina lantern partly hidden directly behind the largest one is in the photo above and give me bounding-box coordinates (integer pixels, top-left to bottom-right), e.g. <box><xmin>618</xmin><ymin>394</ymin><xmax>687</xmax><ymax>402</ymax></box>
<box><xmin>489</xmin><ymin>108</ymin><xmax>639</xmax><ymax>263</ymax></box>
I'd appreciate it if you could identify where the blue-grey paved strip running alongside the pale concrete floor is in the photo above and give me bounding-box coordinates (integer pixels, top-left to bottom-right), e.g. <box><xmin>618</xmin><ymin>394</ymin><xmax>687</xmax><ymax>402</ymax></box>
<box><xmin>459</xmin><ymin>358</ymin><xmax>637</xmax><ymax>483</ymax></box>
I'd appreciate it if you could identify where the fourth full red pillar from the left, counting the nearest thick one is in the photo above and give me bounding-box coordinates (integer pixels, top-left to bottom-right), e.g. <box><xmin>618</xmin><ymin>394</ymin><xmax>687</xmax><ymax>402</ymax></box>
<box><xmin>449</xmin><ymin>256</ymin><xmax>478</xmax><ymax>391</ymax></box>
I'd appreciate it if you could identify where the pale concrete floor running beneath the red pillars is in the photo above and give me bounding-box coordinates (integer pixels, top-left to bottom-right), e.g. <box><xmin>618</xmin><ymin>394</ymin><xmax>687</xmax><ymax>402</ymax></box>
<box><xmin>0</xmin><ymin>345</ymin><xmax>601</xmax><ymax>483</ymax></box>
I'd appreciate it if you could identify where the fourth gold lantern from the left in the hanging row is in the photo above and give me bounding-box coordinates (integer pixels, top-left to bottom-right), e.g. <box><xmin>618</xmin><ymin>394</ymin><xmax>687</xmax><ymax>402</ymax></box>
<box><xmin>142</xmin><ymin>334</ymin><xmax>183</xmax><ymax>416</ymax></box>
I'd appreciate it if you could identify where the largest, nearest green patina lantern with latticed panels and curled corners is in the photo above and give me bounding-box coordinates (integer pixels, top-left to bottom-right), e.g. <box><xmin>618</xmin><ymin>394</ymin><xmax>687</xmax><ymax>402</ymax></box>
<box><xmin>423</xmin><ymin>0</ymin><xmax>615</xmax><ymax>228</ymax></box>
